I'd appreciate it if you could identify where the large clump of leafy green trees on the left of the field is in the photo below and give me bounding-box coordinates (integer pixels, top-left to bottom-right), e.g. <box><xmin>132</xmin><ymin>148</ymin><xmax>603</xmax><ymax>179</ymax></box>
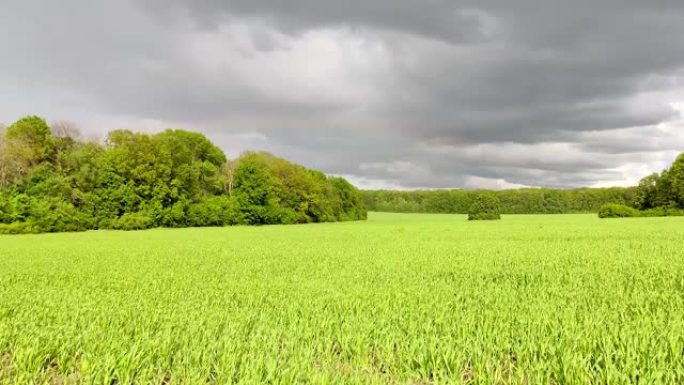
<box><xmin>0</xmin><ymin>116</ymin><xmax>366</xmax><ymax>233</ymax></box>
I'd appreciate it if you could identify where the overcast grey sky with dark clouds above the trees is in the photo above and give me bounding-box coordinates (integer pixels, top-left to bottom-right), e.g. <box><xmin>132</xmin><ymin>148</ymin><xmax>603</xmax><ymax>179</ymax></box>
<box><xmin>0</xmin><ymin>0</ymin><xmax>684</xmax><ymax>188</ymax></box>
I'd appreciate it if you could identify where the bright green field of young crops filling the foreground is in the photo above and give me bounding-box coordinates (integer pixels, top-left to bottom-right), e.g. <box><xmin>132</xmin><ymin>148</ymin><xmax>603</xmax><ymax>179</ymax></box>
<box><xmin>0</xmin><ymin>213</ymin><xmax>684</xmax><ymax>385</ymax></box>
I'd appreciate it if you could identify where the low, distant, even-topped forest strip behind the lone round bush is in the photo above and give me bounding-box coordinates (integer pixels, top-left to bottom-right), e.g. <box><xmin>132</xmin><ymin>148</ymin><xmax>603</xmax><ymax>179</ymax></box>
<box><xmin>361</xmin><ymin>187</ymin><xmax>636</xmax><ymax>214</ymax></box>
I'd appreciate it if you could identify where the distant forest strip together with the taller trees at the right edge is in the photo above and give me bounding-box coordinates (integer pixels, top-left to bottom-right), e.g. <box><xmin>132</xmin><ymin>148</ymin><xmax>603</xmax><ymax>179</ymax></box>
<box><xmin>361</xmin><ymin>154</ymin><xmax>684</xmax><ymax>216</ymax></box>
